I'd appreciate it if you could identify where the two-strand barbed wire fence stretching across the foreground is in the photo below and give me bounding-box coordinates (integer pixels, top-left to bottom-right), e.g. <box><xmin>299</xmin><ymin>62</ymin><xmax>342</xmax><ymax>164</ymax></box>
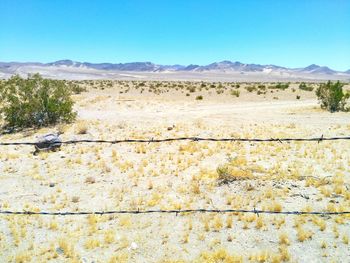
<box><xmin>0</xmin><ymin>135</ymin><xmax>350</xmax><ymax>216</ymax></box>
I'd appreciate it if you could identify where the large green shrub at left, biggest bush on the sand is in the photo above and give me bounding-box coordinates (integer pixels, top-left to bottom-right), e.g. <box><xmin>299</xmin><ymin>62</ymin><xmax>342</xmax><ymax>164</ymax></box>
<box><xmin>0</xmin><ymin>74</ymin><xmax>76</xmax><ymax>129</ymax></box>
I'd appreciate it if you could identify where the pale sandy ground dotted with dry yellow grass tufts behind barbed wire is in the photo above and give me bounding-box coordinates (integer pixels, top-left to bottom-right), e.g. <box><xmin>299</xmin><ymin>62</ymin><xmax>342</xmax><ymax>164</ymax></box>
<box><xmin>0</xmin><ymin>81</ymin><xmax>350</xmax><ymax>262</ymax></box>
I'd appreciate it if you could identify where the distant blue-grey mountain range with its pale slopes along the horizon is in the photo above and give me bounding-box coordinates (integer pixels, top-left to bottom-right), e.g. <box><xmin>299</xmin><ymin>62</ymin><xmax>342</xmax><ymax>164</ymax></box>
<box><xmin>0</xmin><ymin>59</ymin><xmax>350</xmax><ymax>80</ymax></box>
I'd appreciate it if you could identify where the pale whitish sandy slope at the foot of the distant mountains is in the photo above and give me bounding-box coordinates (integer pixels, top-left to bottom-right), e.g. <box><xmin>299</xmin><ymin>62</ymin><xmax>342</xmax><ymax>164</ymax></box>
<box><xmin>0</xmin><ymin>65</ymin><xmax>350</xmax><ymax>82</ymax></box>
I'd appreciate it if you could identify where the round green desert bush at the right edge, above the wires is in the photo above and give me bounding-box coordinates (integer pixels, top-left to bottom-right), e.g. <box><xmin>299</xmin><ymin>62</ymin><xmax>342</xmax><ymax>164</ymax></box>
<box><xmin>316</xmin><ymin>81</ymin><xmax>350</xmax><ymax>112</ymax></box>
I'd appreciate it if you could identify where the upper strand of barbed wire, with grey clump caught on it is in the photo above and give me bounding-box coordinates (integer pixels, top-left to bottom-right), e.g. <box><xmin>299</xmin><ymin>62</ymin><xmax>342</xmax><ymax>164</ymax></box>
<box><xmin>0</xmin><ymin>135</ymin><xmax>350</xmax><ymax>146</ymax></box>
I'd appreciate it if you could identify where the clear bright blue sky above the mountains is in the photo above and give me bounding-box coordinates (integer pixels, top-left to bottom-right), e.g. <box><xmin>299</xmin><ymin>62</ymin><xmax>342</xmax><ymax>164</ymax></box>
<box><xmin>0</xmin><ymin>0</ymin><xmax>350</xmax><ymax>70</ymax></box>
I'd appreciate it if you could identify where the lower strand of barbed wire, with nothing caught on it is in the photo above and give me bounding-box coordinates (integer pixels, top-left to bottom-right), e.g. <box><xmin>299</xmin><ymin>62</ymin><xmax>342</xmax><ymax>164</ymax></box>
<box><xmin>0</xmin><ymin>209</ymin><xmax>350</xmax><ymax>216</ymax></box>
